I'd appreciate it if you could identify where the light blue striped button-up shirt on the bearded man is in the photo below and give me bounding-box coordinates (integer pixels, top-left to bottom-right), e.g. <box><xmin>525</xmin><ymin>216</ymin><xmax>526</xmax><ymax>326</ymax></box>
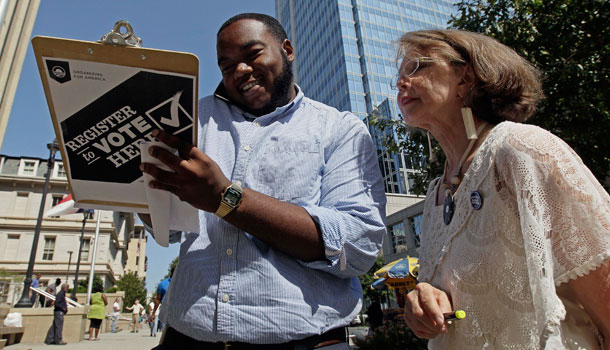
<box><xmin>160</xmin><ymin>89</ymin><xmax>385</xmax><ymax>344</ymax></box>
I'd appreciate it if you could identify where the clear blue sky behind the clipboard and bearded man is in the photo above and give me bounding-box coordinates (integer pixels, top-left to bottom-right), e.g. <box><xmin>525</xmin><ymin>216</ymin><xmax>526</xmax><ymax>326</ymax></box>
<box><xmin>0</xmin><ymin>0</ymin><xmax>275</xmax><ymax>291</ymax></box>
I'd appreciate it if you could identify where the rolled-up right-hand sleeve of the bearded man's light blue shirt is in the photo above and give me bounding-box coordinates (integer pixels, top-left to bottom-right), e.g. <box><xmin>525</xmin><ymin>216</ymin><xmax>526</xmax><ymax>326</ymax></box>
<box><xmin>303</xmin><ymin>115</ymin><xmax>386</xmax><ymax>277</ymax></box>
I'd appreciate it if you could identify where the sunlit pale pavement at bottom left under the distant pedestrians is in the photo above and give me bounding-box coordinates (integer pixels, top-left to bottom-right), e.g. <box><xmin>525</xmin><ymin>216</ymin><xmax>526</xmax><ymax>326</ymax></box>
<box><xmin>4</xmin><ymin>327</ymin><xmax>161</xmax><ymax>350</ymax></box>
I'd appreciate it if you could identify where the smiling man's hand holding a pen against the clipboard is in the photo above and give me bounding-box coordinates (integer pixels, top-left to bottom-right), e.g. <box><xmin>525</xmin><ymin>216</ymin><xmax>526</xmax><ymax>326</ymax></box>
<box><xmin>140</xmin><ymin>130</ymin><xmax>231</xmax><ymax>213</ymax></box>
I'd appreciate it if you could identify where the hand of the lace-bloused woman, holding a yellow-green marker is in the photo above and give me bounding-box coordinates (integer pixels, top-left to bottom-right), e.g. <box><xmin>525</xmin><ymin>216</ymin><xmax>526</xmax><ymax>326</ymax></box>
<box><xmin>405</xmin><ymin>283</ymin><xmax>452</xmax><ymax>339</ymax></box>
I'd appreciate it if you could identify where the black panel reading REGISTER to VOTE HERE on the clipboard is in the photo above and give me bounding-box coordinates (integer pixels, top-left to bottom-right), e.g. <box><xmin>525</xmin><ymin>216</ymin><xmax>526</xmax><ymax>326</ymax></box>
<box><xmin>61</xmin><ymin>72</ymin><xmax>194</xmax><ymax>183</ymax></box>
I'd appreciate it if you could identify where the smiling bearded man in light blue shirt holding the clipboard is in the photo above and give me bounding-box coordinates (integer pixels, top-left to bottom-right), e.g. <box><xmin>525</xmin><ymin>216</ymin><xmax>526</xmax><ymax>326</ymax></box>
<box><xmin>141</xmin><ymin>14</ymin><xmax>385</xmax><ymax>350</ymax></box>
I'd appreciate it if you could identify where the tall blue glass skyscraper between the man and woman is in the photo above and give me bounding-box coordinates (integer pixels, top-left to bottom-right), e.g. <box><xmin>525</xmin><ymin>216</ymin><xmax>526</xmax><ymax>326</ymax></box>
<box><xmin>276</xmin><ymin>0</ymin><xmax>456</xmax><ymax>194</ymax></box>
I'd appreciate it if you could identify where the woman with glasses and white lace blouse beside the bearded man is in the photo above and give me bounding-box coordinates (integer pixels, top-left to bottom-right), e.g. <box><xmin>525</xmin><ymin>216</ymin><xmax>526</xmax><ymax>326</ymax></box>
<box><xmin>396</xmin><ymin>30</ymin><xmax>610</xmax><ymax>349</ymax></box>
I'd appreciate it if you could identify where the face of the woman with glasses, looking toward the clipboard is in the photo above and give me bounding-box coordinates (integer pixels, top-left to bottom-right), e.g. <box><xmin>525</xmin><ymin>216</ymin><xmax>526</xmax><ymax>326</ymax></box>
<box><xmin>396</xmin><ymin>53</ymin><xmax>461</xmax><ymax>130</ymax></box>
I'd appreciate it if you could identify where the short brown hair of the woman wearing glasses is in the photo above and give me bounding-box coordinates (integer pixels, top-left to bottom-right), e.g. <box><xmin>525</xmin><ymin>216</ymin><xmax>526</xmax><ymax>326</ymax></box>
<box><xmin>397</xmin><ymin>30</ymin><xmax>544</xmax><ymax>124</ymax></box>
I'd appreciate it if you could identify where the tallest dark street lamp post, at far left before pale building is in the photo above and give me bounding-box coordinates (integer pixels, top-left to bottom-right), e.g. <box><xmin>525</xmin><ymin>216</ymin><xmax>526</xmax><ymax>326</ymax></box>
<box><xmin>15</xmin><ymin>139</ymin><xmax>59</xmax><ymax>307</ymax></box>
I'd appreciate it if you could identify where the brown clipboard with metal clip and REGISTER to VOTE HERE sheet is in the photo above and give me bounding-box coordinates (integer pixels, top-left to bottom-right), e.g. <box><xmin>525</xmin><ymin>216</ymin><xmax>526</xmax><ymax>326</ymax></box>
<box><xmin>32</xmin><ymin>21</ymin><xmax>199</xmax><ymax>213</ymax></box>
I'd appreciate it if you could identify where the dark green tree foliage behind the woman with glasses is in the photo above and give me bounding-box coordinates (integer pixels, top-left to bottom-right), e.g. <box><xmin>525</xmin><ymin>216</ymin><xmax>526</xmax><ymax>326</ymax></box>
<box><xmin>373</xmin><ymin>0</ymin><xmax>610</xmax><ymax>194</ymax></box>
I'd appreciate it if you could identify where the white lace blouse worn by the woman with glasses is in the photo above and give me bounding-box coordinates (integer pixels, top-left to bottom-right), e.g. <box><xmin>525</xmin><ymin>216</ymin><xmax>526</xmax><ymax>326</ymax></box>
<box><xmin>419</xmin><ymin>122</ymin><xmax>610</xmax><ymax>350</ymax></box>
